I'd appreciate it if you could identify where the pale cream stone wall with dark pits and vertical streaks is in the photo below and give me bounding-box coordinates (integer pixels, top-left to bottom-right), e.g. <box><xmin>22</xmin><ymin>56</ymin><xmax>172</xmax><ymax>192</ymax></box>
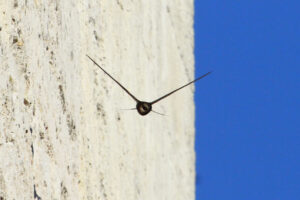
<box><xmin>0</xmin><ymin>0</ymin><xmax>194</xmax><ymax>200</ymax></box>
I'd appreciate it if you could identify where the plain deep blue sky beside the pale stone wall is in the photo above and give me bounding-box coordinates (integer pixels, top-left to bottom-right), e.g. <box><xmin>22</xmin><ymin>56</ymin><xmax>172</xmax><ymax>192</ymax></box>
<box><xmin>195</xmin><ymin>0</ymin><xmax>300</xmax><ymax>200</ymax></box>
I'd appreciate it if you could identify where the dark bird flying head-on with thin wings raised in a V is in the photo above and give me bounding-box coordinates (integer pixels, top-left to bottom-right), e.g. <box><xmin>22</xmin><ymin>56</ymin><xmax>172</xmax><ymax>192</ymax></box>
<box><xmin>86</xmin><ymin>55</ymin><xmax>211</xmax><ymax>116</ymax></box>
